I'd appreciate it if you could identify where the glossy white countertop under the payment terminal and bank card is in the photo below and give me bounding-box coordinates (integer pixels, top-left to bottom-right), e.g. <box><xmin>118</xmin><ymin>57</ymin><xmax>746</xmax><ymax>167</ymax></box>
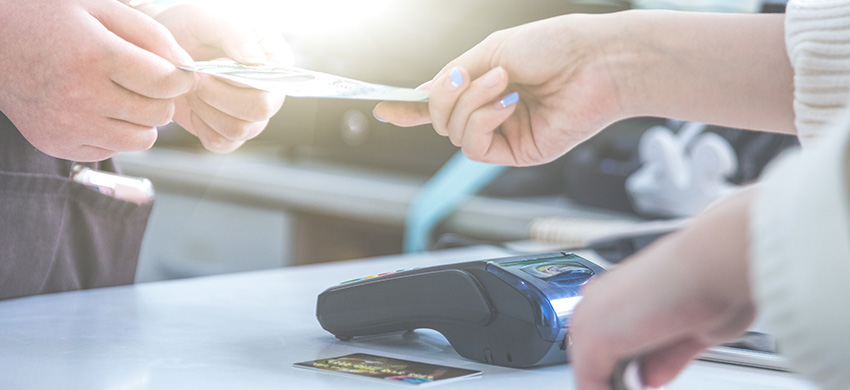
<box><xmin>0</xmin><ymin>247</ymin><xmax>814</xmax><ymax>390</ymax></box>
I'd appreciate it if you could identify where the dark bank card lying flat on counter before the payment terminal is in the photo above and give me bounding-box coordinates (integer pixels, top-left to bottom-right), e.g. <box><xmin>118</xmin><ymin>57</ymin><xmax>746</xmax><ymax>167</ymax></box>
<box><xmin>294</xmin><ymin>353</ymin><xmax>481</xmax><ymax>386</ymax></box>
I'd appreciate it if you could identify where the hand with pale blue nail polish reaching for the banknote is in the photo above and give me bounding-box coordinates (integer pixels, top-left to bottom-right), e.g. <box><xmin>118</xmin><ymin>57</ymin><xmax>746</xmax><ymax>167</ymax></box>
<box><xmin>375</xmin><ymin>15</ymin><xmax>624</xmax><ymax>166</ymax></box>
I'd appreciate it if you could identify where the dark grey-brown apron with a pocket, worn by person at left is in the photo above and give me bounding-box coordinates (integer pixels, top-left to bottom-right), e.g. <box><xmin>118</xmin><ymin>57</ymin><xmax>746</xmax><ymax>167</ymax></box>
<box><xmin>0</xmin><ymin>113</ymin><xmax>151</xmax><ymax>299</ymax></box>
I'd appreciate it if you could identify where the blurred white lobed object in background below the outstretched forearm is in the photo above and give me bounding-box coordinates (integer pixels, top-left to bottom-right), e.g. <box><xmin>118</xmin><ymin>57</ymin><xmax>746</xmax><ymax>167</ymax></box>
<box><xmin>626</xmin><ymin>123</ymin><xmax>738</xmax><ymax>217</ymax></box>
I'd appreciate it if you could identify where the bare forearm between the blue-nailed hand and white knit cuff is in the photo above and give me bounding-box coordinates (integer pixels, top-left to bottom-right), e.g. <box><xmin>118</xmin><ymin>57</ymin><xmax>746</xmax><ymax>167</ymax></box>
<box><xmin>606</xmin><ymin>11</ymin><xmax>796</xmax><ymax>134</ymax></box>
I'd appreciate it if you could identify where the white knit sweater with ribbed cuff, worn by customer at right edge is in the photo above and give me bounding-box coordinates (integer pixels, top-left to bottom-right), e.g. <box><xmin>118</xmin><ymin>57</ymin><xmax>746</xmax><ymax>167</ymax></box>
<box><xmin>750</xmin><ymin>0</ymin><xmax>850</xmax><ymax>389</ymax></box>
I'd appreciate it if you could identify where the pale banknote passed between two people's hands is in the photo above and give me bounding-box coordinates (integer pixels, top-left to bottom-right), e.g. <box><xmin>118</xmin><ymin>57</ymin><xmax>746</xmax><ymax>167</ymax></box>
<box><xmin>180</xmin><ymin>61</ymin><xmax>428</xmax><ymax>102</ymax></box>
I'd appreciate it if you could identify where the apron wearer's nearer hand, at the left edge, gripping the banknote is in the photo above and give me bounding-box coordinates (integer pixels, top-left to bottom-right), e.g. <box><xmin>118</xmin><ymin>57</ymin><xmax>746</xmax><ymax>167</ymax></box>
<box><xmin>0</xmin><ymin>0</ymin><xmax>193</xmax><ymax>161</ymax></box>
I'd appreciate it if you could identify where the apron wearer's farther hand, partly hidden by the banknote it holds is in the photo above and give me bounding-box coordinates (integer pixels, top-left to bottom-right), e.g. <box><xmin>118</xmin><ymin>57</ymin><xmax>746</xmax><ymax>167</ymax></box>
<box><xmin>147</xmin><ymin>4</ymin><xmax>292</xmax><ymax>153</ymax></box>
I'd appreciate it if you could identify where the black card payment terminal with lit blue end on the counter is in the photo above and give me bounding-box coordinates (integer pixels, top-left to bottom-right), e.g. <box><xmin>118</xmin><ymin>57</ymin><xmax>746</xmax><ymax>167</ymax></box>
<box><xmin>316</xmin><ymin>252</ymin><xmax>604</xmax><ymax>367</ymax></box>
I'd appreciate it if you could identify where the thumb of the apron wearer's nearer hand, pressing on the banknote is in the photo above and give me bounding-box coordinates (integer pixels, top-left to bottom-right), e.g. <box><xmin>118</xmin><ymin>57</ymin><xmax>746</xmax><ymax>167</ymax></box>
<box><xmin>92</xmin><ymin>1</ymin><xmax>194</xmax><ymax>67</ymax></box>
